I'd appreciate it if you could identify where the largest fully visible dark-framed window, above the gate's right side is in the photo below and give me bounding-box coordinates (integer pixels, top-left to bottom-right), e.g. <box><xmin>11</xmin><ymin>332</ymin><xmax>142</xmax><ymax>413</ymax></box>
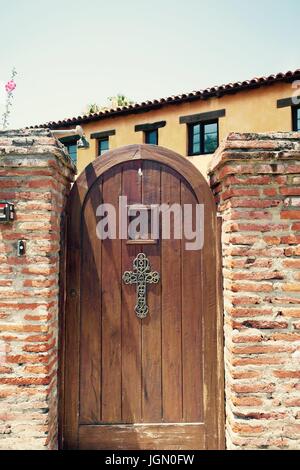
<box><xmin>188</xmin><ymin>121</ymin><xmax>219</xmax><ymax>156</ymax></box>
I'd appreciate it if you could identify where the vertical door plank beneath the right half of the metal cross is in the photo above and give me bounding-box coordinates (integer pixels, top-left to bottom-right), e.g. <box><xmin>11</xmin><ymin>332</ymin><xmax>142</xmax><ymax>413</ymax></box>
<box><xmin>142</xmin><ymin>161</ymin><xmax>163</xmax><ymax>423</ymax></box>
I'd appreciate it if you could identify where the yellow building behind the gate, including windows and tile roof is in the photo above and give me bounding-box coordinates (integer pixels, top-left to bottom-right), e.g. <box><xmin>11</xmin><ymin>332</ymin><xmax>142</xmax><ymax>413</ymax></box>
<box><xmin>34</xmin><ymin>70</ymin><xmax>300</xmax><ymax>175</ymax></box>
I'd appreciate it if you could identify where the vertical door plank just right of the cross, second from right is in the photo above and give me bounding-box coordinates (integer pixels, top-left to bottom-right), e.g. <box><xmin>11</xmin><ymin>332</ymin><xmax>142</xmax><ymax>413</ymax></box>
<box><xmin>161</xmin><ymin>167</ymin><xmax>183</xmax><ymax>423</ymax></box>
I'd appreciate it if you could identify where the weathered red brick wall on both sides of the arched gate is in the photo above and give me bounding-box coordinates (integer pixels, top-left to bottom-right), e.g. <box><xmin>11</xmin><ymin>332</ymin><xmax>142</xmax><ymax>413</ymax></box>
<box><xmin>0</xmin><ymin>130</ymin><xmax>300</xmax><ymax>449</ymax></box>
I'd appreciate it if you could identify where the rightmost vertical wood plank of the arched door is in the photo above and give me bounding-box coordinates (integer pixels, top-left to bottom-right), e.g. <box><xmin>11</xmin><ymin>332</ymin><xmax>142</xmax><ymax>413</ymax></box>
<box><xmin>181</xmin><ymin>181</ymin><xmax>204</xmax><ymax>423</ymax></box>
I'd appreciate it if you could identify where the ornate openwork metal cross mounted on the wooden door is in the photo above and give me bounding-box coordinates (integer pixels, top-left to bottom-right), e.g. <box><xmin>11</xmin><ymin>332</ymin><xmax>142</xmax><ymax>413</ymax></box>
<box><xmin>123</xmin><ymin>253</ymin><xmax>160</xmax><ymax>319</ymax></box>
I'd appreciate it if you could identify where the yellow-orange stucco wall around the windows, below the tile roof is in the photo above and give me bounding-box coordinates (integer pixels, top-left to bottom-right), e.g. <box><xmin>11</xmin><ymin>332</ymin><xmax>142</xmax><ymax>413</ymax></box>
<box><xmin>72</xmin><ymin>83</ymin><xmax>295</xmax><ymax>176</ymax></box>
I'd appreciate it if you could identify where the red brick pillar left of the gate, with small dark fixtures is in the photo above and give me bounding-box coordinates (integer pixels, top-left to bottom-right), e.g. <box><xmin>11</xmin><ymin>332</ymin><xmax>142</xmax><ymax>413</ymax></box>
<box><xmin>0</xmin><ymin>130</ymin><xmax>74</xmax><ymax>449</ymax></box>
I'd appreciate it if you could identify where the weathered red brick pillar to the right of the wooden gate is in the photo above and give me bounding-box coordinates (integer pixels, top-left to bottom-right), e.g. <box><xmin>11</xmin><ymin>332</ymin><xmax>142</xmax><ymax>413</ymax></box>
<box><xmin>210</xmin><ymin>133</ymin><xmax>300</xmax><ymax>449</ymax></box>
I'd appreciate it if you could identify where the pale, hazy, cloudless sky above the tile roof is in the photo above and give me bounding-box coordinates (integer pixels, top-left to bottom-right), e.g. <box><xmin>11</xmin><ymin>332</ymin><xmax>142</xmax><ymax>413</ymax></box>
<box><xmin>0</xmin><ymin>0</ymin><xmax>300</xmax><ymax>128</ymax></box>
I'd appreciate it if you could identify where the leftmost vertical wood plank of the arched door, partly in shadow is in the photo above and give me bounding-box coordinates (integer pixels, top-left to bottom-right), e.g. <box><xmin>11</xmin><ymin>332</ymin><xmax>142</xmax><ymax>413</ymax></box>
<box><xmin>80</xmin><ymin>188</ymin><xmax>102</xmax><ymax>424</ymax></box>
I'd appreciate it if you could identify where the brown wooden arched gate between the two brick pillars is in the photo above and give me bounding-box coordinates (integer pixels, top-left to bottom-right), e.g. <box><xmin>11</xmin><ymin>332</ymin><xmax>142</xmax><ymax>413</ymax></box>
<box><xmin>62</xmin><ymin>145</ymin><xmax>224</xmax><ymax>450</ymax></box>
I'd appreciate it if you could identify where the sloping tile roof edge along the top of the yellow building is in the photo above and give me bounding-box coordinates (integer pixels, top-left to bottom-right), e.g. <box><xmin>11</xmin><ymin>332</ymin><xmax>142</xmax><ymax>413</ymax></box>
<box><xmin>32</xmin><ymin>69</ymin><xmax>300</xmax><ymax>129</ymax></box>
